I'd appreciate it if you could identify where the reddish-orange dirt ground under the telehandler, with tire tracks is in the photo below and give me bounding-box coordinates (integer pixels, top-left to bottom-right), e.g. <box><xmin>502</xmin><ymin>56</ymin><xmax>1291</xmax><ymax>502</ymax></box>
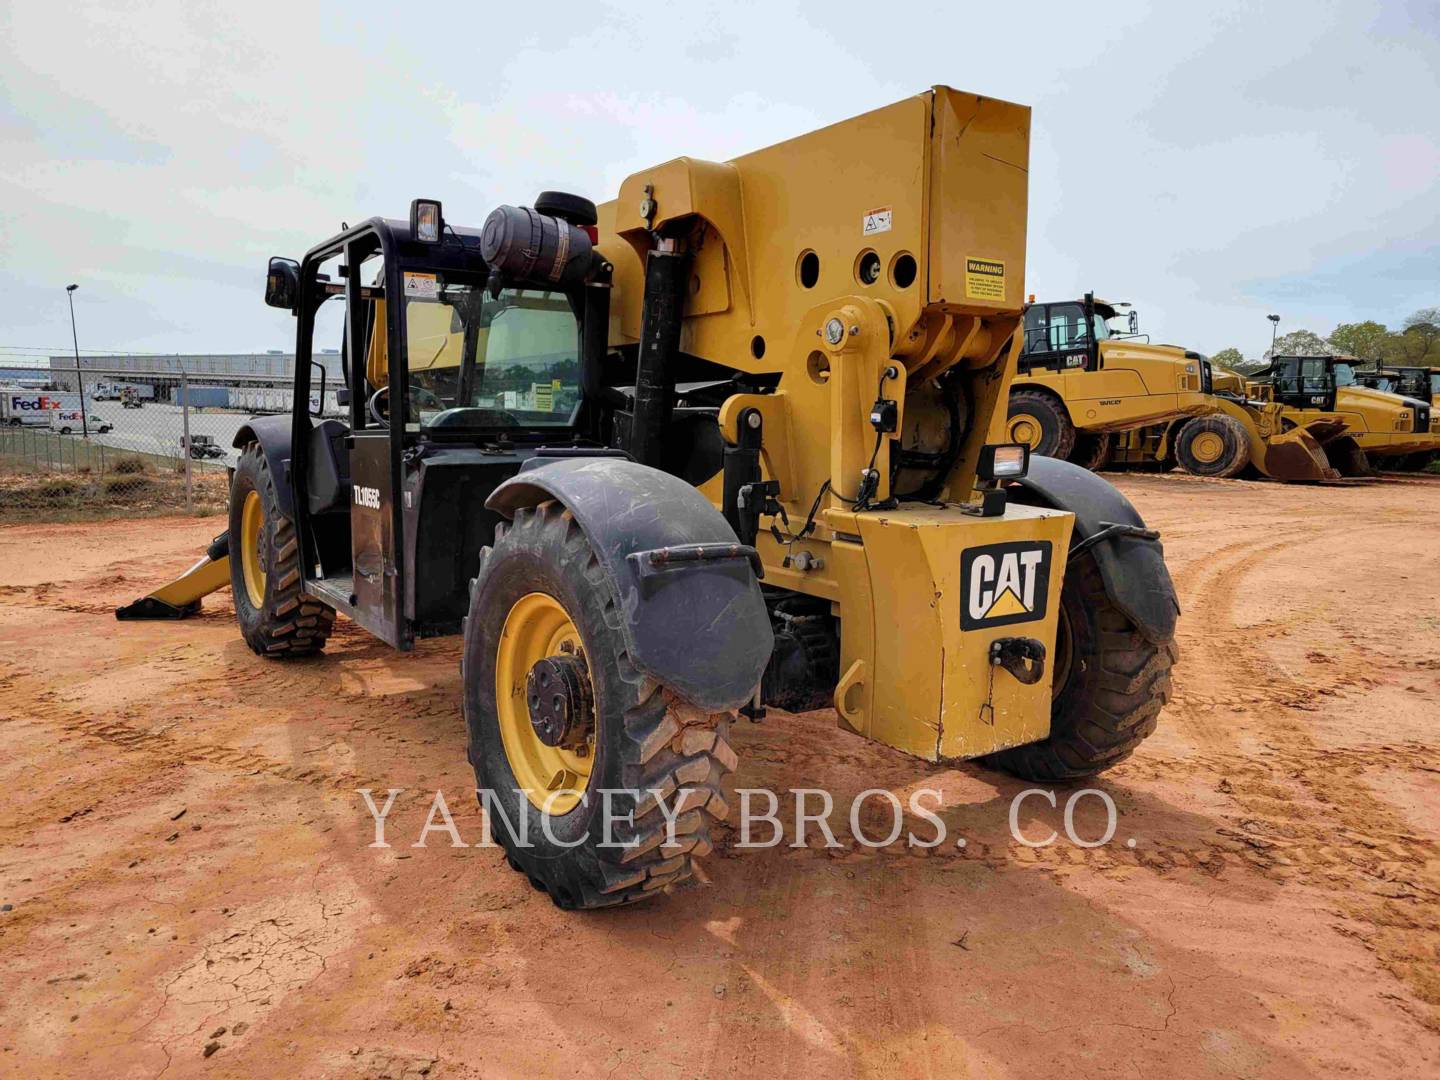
<box><xmin>0</xmin><ymin>475</ymin><xmax>1440</xmax><ymax>1080</ymax></box>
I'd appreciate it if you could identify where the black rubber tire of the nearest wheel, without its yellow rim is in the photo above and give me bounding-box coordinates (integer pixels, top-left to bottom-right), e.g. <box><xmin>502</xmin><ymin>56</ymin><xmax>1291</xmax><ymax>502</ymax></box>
<box><xmin>461</xmin><ymin>501</ymin><xmax>737</xmax><ymax>909</ymax></box>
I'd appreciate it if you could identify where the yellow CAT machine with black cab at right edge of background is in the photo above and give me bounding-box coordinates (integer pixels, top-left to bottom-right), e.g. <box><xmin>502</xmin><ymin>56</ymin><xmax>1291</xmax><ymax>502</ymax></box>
<box><xmin>1246</xmin><ymin>356</ymin><xmax>1440</xmax><ymax>477</ymax></box>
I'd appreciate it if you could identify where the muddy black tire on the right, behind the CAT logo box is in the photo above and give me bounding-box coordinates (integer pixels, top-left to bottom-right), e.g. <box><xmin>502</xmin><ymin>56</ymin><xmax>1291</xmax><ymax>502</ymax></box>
<box><xmin>985</xmin><ymin>552</ymin><xmax>1178</xmax><ymax>783</ymax></box>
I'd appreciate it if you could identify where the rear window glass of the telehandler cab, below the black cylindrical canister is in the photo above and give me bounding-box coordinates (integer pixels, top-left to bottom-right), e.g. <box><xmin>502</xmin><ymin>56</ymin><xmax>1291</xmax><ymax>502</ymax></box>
<box><xmin>405</xmin><ymin>274</ymin><xmax>580</xmax><ymax>428</ymax></box>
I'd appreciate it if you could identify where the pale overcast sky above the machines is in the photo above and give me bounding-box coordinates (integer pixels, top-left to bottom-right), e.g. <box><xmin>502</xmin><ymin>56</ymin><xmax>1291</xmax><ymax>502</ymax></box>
<box><xmin>0</xmin><ymin>0</ymin><xmax>1440</xmax><ymax>363</ymax></box>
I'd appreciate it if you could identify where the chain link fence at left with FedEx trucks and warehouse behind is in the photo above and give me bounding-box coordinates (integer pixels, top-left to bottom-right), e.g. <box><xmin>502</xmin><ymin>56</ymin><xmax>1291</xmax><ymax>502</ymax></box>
<box><xmin>0</xmin><ymin>366</ymin><xmax>331</xmax><ymax>518</ymax></box>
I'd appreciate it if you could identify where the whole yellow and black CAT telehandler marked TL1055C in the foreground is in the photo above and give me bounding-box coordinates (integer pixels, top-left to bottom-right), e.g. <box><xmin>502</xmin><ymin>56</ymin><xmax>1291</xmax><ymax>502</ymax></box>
<box><xmin>118</xmin><ymin>86</ymin><xmax>1178</xmax><ymax>909</ymax></box>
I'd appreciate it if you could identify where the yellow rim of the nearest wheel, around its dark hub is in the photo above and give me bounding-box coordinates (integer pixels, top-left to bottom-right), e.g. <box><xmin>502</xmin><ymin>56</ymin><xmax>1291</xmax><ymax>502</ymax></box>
<box><xmin>495</xmin><ymin>592</ymin><xmax>595</xmax><ymax>816</ymax></box>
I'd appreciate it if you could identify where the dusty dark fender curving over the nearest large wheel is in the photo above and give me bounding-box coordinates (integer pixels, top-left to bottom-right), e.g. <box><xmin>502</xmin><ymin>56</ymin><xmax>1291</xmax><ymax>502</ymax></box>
<box><xmin>485</xmin><ymin>458</ymin><xmax>775</xmax><ymax>711</ymax></box>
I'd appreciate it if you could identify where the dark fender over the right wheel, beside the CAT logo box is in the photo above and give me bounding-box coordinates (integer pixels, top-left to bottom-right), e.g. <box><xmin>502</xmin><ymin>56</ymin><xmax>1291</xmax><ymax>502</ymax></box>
<box><xmin>1009</xmin><ymin>456</ymin><xmax>1179</xmax><ymax>645</ymax></box>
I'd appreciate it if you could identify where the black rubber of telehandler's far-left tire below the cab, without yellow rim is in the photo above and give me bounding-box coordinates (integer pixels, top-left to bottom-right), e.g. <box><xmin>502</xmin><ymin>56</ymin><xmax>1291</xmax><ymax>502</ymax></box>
<box><xmin>229</xmin><ymin>442</ymin><xmax>336</xmax><ymax>658</ymax></box>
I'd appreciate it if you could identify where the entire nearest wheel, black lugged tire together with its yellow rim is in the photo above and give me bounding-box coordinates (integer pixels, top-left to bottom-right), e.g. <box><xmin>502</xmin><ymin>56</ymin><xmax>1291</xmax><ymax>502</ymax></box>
<box><xmin>461</xmin><ymin>501</ymin><xmax>737</xmax><ymax>909</ymax></box>
